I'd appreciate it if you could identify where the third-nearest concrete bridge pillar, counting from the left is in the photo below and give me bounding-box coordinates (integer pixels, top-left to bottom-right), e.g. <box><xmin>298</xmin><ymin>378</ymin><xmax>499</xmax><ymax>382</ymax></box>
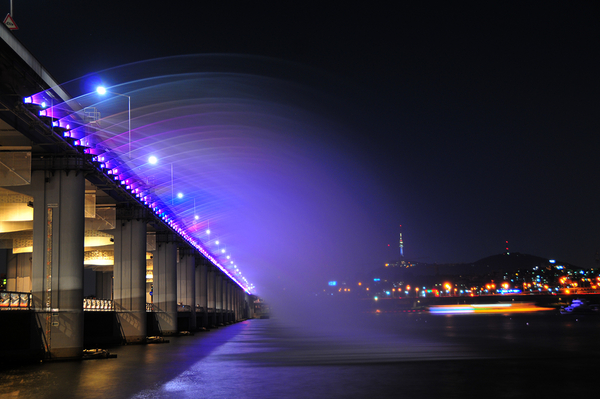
<box><xmin>153</xmin><ymin>242</ymin><xmax>177</xmax><ymax>335</ymax></box>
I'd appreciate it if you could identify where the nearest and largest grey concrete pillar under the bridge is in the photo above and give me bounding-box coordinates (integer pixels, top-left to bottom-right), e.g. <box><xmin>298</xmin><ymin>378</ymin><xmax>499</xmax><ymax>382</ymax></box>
<box><xmin>31</xmin><ymin>170</ymin><xmax>85</xmax><ymax>358</ymax></box>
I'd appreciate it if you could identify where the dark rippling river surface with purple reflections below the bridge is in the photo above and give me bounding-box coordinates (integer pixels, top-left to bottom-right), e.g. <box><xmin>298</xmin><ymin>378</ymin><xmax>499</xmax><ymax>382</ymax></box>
<box><xmin>0</xmin><ymin>314</ymin><xmax>600</xmax><ymax>399</ymax></box>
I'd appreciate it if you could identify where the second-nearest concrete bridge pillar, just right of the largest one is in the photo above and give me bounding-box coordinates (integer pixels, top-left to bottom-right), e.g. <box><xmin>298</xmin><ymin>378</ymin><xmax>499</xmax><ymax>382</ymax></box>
<box><xmin>113</xmin><ymin>219</ymin><xmax>146</xmax><ymax>343</ymax></box>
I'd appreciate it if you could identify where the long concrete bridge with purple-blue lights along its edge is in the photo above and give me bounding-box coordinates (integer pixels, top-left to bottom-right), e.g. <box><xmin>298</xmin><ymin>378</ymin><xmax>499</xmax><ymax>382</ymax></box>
<box><xmin>0</xmin><ymin>25</ymin><xmax>252</xmax><ymax>359</ymax></box>
